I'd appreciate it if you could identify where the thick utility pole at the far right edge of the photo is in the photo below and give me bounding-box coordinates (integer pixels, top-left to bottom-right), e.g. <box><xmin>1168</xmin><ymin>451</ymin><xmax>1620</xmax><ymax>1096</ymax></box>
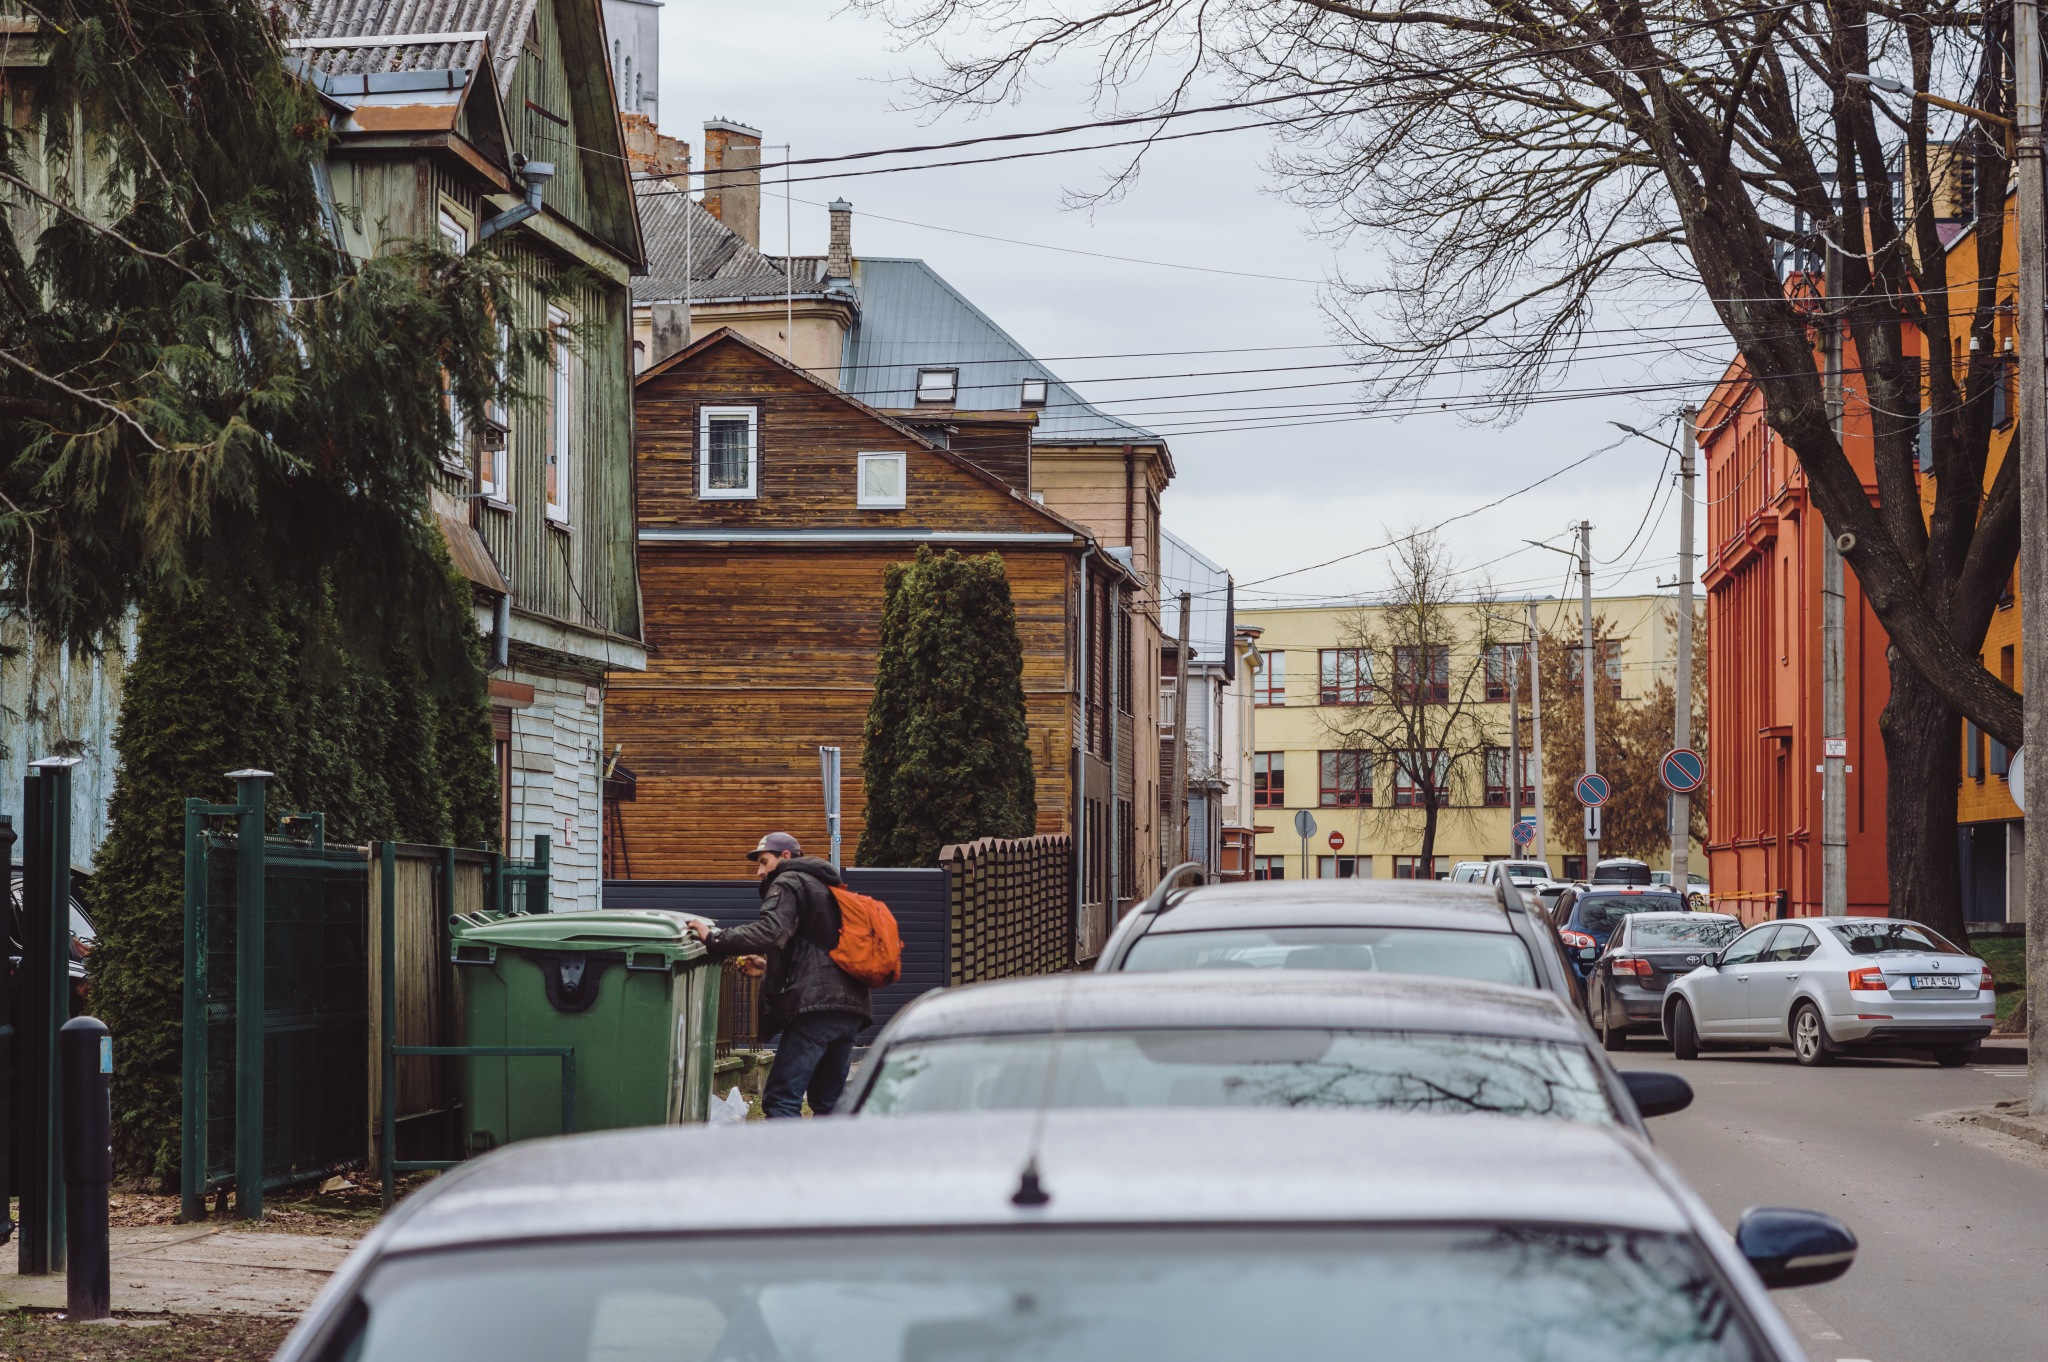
<box><xmin>2007</xmin><ymin>0</ymin><xmax>2048</xmax><ymax>1116</ymax></box>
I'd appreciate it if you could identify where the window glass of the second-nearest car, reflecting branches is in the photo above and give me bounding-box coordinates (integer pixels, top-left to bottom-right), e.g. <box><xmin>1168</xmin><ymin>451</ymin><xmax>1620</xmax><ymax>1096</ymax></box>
<box><xmin>860</xmin><ymin>1030</ymin><xmax>1616</xmax><ymax>1124</ymax></box>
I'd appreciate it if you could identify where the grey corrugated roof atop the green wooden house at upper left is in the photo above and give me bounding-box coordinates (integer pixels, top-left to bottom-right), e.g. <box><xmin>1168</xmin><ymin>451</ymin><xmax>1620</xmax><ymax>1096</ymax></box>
<box><xmin>293</xmin><ymin>0</ymin><xmax>539</xmax><ymax>92</ymax></box>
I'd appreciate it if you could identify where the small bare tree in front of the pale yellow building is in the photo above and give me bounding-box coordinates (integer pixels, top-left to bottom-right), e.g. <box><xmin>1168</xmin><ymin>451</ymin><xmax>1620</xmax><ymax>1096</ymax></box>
<box><xmin>1317</xmin><ymin>533</ymin><xmax>1513</xmax><ymax>875</ymax></box>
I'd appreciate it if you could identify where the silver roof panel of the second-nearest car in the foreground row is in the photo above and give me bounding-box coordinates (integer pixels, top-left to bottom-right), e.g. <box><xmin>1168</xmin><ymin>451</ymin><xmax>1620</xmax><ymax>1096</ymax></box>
<box><xmin>872</xmin><ymin>969</ymin><xmax>1583</xmax><ymax>1045</ymax></box>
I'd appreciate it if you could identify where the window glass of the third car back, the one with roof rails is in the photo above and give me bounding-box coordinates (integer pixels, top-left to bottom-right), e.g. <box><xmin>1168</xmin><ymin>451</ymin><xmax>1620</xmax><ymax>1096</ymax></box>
<box><xmin>1124</xmin><ymin>928</ymin><xmax>1536</xmax><ymax>987</ymax></box>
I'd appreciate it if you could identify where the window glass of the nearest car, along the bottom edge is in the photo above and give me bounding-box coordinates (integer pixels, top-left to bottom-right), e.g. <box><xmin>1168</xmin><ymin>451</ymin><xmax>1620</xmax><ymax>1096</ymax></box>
<box><xmin>344</xmin><ymin>1220</ymin><xmax>1765</xmax><ymax>1362</ymax></box>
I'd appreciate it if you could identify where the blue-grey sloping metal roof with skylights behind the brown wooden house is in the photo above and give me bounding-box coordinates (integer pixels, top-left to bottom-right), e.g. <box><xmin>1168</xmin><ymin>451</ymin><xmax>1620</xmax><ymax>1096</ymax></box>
<box><xmin>846</xmin><ymin>258</ymin><xmax>1159</xmax><ymax>444</ymax></box>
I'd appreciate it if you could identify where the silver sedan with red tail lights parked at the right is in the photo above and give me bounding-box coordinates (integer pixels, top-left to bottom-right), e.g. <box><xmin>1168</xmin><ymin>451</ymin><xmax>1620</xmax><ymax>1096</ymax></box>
<box><xmin>1663</xmin><ymin>918</ymin><xmax>1997</xmax><ymax>1069</ymax></box>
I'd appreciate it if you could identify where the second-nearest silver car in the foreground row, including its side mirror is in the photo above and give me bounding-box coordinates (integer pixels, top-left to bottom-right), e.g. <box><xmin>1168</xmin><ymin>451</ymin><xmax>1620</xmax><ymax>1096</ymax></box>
<box><xmin>846</xmin><ymin>969</ymin><xmax>1692</xmax><ymax>1131</ymax></box>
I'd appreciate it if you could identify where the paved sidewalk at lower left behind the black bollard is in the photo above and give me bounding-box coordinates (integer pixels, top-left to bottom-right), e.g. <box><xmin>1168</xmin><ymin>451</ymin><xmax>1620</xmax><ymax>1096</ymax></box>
<box><xmin>0</xmin><ymin>1223</ymin><xmax>360</xmax><ymax>1319</ymax></box>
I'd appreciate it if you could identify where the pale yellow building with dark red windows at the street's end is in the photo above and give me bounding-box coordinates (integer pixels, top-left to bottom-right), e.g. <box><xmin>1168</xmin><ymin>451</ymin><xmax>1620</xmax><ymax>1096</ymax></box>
<box><xmin>1237</xmin><ymin>596</ymin><xmax>1706</xmax><ymax>879</ymax></box>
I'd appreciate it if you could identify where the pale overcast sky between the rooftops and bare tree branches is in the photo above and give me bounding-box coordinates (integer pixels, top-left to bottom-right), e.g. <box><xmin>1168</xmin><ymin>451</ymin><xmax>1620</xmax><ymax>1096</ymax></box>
<box><xmin>662</xmin><ymin>0</ymin><xmax>1729</xmax><ymax>606</ymax></box>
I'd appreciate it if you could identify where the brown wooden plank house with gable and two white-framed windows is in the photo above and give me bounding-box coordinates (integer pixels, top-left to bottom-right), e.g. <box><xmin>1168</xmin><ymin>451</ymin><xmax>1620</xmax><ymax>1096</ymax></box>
<box><xmin>606</xmin><ymin>328</ymin><xmax>1139</xmax><ymax>880</ymax></box>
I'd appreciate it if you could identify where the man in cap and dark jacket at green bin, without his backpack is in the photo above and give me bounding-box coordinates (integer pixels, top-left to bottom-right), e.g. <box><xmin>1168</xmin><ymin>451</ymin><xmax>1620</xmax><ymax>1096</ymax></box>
<box><xmin>690</xmin><ymin>832</ymin><xmax>876</xmax><ymax>1120</ymax></box>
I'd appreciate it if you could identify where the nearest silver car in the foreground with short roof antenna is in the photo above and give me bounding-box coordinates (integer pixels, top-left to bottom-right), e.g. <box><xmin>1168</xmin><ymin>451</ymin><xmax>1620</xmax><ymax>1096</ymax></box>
<box><xmin>276</xmin><ymin>1110</ymin><xmax>1855</xmax><ymax>1362</ymax></box>
